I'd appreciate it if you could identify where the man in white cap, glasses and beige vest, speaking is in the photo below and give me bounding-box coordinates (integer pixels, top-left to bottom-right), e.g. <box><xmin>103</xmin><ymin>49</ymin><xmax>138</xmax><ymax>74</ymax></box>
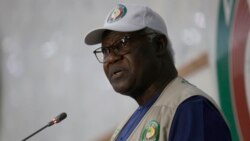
<box><xmin>85</xmin><ymin>4</ymin><xmax>231</xmax><ymax>141</ymax></box>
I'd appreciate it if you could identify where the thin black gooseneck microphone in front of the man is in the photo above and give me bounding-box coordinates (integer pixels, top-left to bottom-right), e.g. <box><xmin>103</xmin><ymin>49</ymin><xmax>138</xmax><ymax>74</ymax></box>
<box><xmin>22</xmin><ymin>112</ymin><xmax>67</xmax><ymax>141</ymax></box>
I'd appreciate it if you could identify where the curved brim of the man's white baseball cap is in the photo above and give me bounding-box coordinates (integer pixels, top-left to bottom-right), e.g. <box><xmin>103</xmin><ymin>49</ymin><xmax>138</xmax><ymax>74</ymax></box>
<box><xmin>85</xmin><ymin>24</ymin><xmax>145</xmax><ymax>45</ymax></box>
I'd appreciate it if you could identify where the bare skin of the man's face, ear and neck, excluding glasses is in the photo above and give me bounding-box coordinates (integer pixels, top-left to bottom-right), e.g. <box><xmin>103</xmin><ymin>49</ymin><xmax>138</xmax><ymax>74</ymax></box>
<box><xmin>102</xmin><ymin>31</ymin><xmax>177</xmax><ymax>105</ymax></box>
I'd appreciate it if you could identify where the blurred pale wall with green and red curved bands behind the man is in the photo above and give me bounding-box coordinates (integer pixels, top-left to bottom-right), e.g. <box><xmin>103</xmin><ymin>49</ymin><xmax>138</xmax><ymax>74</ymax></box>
<box><xmin>0</xmin><ymin>0</ymin><xmax>250</xmax><ymax>141</ymax></box>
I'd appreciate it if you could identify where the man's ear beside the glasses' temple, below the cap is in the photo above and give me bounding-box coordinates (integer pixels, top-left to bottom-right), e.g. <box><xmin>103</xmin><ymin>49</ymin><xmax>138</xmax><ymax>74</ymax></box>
<box><xmin>154</xmin><ymin>35</ymin><xmax>168</xmax><ymax>56</ymax></box>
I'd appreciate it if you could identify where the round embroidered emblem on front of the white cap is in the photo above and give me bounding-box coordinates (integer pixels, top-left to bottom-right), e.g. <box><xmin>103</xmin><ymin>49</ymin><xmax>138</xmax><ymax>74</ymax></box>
<box><xmin>107</xmin><ymin>4</ymin><xmax>127</xmax><ymax>23</ymax></box>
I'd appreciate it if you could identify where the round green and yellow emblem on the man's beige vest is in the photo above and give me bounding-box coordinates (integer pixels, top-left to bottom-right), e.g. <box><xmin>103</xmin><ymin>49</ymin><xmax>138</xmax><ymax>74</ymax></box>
<box><xmin>141</xmin><ymin>120</ymin><xmax>160</xmax><ymax>141</ymax></box>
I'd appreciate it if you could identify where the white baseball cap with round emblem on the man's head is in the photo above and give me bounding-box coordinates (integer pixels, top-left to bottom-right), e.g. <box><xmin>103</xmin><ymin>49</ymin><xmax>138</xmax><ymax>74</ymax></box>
<box><xmin>85</xmin><ymin>4</ymin><xmax>168</xmax><ymax>45</ymax></box>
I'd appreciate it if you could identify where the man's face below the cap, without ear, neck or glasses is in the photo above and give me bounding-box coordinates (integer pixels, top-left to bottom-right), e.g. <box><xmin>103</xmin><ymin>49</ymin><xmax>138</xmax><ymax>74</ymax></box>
<box><xmin>102</xmin><ymin>32</ymin><xmax>159</xmax><ymax>97</ymax></box>
